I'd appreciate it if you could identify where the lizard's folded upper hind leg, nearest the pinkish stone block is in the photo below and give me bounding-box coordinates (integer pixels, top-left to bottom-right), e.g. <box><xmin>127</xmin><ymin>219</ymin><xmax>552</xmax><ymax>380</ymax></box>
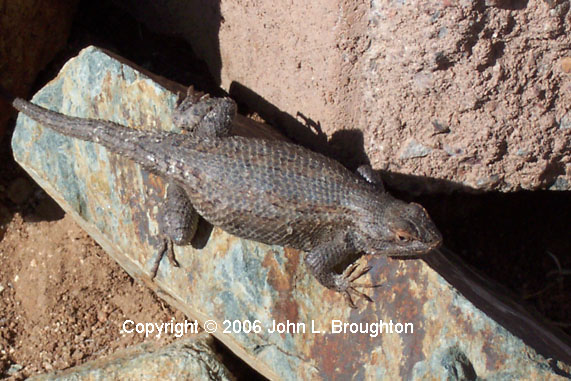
<box><xmin>173</xmin><ymin>87</ymin><xmax>237</xmax><ymax>137</ymax></box>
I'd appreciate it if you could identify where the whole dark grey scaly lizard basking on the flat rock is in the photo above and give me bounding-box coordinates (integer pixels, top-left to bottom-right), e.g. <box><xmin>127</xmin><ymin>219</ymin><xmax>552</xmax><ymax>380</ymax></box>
<box><xmin>4</xmin><ymin>86</ymin><xmax>442</xmax><ymax>306</ymax></box>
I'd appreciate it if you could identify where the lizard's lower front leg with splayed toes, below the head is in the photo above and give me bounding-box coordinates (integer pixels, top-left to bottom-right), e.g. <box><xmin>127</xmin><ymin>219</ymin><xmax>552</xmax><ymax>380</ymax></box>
<box><xmin>305</xmin><ymin>233</ymin><xmax>378</xmax><ymax>308</ymax></box>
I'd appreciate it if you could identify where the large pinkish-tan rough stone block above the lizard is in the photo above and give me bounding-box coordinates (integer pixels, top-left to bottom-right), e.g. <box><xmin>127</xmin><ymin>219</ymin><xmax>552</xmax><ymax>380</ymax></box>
<box><xmin>121</xmin><ymin>0</ymin><xmax>571</xmax><ymax>191</ymax></box>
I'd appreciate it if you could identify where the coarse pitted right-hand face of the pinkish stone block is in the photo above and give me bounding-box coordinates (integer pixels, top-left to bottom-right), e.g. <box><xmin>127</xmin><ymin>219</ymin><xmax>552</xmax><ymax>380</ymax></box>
<box><xmin>359</xmin><ymin>0</ymin><xmax>571</xmax><ymax>191</ymax></box>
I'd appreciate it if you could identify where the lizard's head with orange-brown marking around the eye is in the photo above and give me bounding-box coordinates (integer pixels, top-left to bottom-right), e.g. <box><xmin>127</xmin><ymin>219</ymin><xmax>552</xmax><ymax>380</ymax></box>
<box><xmin>356</xmin><ymin>197</ymin><xmax>442</xmax><ymax>256</ymax></box>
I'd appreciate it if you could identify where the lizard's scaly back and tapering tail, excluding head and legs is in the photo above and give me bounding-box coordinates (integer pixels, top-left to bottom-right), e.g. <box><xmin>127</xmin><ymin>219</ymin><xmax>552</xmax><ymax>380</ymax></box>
<box><xmin>8</xmin><ymin>98</ymin><xmax>382</xmax><ymax>250</ymax></box>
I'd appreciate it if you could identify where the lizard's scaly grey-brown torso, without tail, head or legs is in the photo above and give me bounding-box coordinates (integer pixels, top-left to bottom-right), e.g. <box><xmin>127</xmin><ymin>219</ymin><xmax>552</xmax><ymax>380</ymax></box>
<box><xmin>173</xmin><ymin>136</ymin><xmax>371</xmax><ymax>250</ymax></box>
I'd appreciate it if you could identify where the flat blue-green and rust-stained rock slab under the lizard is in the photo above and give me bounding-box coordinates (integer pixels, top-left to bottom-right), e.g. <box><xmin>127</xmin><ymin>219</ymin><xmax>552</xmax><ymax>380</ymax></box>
<box><xmin>13</xmin><ymin>48</ymin><xmax>570</xmax><ymax>379</ymax></box>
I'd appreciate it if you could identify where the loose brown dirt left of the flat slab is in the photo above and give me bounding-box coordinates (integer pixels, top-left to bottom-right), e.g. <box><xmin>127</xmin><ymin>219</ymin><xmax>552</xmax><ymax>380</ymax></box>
<box><xmin>0</xmin><ymin>178</ymin><xmax>184</xmax><ymax>380</ymax></box>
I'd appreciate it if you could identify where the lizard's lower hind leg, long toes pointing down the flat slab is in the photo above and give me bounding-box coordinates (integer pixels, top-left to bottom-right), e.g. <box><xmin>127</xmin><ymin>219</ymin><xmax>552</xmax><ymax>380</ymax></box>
<box><xmin>151</xmin><ymin>183</ymin><xmax>198</xmax><ymax>279</ymax></box>
